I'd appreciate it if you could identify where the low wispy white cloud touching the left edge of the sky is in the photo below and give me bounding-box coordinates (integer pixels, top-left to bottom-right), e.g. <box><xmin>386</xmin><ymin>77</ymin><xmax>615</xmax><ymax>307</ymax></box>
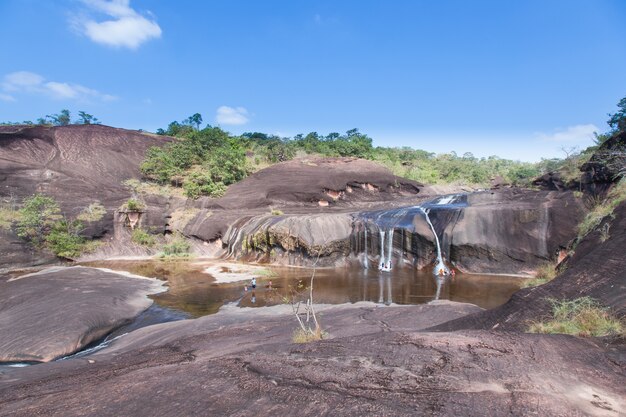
<box><xmin>0</xmin><ymin>71</ymin><xmax>117</xmax><ymax>101</ymax></box>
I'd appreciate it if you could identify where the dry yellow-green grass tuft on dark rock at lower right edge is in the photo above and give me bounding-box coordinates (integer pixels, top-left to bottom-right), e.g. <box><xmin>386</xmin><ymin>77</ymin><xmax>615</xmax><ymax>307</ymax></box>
<box><xmin>528</xmin><ymin>297</ymin><xmax>626</xmax><ymax>337</ymax></box>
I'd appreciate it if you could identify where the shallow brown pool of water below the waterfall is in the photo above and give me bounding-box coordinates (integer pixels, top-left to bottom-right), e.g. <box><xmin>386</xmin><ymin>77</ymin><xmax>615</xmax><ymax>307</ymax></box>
<box><xmin>81</xmin><ymin>260</ymin><xmax>522</xmax><ymax>317</ymax></box>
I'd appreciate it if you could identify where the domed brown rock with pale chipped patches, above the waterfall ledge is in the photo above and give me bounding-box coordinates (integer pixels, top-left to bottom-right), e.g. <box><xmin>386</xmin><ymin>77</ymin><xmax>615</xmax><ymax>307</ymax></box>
<box><xmin>182</xmin><ymin>158</ymin><xmax>423</xmax><ymax>241</ymax></box>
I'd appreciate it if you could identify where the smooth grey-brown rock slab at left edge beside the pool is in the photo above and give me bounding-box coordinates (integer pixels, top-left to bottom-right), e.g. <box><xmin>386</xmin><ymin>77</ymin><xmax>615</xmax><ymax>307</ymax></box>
<box><xmin>0</xmin><ymin>267</ymin><xmax>163</xmax><ymax>362</ymax></box>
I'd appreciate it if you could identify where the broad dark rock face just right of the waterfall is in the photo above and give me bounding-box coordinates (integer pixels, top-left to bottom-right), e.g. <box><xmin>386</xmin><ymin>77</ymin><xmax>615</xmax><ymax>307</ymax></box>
<box><xmin>443</xmin><ymin>190</ymin><xmax>584</xmax><ymax>273</ymax></box>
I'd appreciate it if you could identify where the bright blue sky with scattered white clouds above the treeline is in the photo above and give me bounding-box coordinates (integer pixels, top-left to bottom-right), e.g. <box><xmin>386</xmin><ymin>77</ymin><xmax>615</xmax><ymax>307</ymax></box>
<box><xmin>0</xmin><ymin>0</ymin><xmax>626</xmax><ymax>161</ymax></box>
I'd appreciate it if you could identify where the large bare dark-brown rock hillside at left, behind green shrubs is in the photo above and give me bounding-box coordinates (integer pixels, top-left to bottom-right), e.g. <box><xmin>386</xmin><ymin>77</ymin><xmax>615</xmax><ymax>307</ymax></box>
<box><xmin>0</xmin><ymin>125</ymin><xmax>171</xmax><ymax>269</ymax></box>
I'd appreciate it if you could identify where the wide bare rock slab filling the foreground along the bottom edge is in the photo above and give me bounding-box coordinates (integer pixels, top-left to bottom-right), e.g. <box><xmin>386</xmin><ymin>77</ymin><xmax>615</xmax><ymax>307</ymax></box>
<box><xmin>0</xmin><ymin>303</ymin><xmax>626</xmax><ymax>417</ymax></box>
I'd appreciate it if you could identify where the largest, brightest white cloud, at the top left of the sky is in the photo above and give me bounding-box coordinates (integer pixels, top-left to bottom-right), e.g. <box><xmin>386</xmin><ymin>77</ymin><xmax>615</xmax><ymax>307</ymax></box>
<box><xmin>72</xmin><ymin>0</ymin><xmax>162</xmax><ymax>49</ymax></box>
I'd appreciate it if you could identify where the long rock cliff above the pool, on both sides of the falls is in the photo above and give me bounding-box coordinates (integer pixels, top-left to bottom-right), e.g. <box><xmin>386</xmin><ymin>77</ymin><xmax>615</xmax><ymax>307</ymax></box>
<box><xmin>223</xmin><ymin>189</ymin><xmax>584</xmax><ymax>274</ymax></box>
